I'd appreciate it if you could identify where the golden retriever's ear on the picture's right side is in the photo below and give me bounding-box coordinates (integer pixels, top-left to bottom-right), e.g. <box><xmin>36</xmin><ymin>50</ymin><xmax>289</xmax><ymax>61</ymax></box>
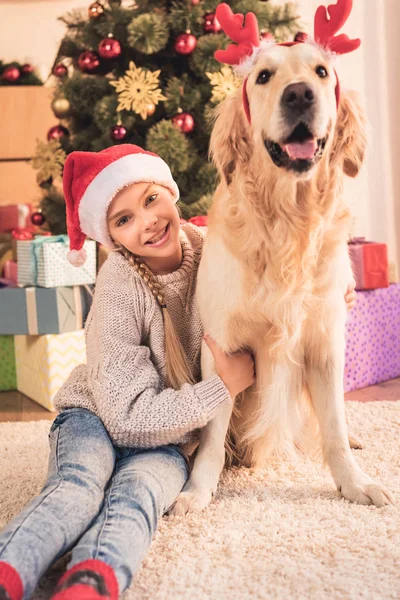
<box><xmin>332</xmin><ymin>91</ymin><xmax>367</xmax><ymax>177</ymax></box>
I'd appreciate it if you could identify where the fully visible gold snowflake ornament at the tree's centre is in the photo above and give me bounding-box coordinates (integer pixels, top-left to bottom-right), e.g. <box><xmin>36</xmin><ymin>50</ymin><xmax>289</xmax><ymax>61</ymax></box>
<box><xmin>110</xmin><ymin>61</ymin><xmax>167</xmax><ymax>120</ymax></box>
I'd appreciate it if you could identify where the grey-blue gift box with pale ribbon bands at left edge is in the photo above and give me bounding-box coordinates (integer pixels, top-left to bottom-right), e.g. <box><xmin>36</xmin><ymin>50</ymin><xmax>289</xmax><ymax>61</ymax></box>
<box><xmin>0</xmin><ymin>286</ymin><xmax>93</xmax><ymax>335</ymax></box>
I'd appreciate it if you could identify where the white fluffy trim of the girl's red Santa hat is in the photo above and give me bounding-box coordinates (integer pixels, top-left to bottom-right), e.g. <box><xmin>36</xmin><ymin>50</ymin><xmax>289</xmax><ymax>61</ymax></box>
<box><xmin>79</xmin><ymin>153</ymin><xmax>179</xmax><ymax>248</ymax></box>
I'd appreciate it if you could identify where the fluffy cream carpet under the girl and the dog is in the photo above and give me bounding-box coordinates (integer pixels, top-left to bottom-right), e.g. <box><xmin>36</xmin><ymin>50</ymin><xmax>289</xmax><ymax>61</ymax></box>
<box><xmin>0</xmin><ymin>401</ymin><xmax>400</xmax><ymax>600</ymax></box>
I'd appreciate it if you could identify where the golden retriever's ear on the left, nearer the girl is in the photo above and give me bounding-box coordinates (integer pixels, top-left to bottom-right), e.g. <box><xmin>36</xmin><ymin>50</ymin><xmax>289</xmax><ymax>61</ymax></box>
<box><xmin>210</xmin><ymin>92</ymin><xmax>251</xmax><ymax>185</ymax></box>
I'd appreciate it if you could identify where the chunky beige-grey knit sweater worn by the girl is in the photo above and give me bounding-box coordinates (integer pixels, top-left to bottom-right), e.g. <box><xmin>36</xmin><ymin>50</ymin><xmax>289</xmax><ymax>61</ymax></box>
<box><xmin>55</xmin><ymin>224</ymin><xmax>231</xmax><ymax>448</ymax></box>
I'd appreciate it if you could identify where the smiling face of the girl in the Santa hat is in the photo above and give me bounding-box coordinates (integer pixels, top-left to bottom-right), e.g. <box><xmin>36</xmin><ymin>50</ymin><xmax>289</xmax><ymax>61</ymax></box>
<box><xmin>107</xmin><ymin>182</ymin><xmax>182</xmax><ymax>271</ymax></box>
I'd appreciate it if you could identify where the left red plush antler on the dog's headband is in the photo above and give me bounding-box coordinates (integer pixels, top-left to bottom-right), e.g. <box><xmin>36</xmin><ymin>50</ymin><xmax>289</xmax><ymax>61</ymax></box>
<box><xmin>214</xmin><ymin>3</ymin><xmax>260</xmax><ymax>65</ymax></box>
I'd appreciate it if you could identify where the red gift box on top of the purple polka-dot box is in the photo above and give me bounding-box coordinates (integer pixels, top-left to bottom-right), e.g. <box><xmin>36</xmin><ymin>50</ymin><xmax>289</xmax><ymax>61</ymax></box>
<box><xmin>348</xmin><ymin>238</ymin><xmax>389</xmax><ymax>290</ymax></box>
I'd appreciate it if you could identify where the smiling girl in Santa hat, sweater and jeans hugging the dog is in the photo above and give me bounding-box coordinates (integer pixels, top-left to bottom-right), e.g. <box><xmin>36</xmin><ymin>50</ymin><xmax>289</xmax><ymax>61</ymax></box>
<box><xmin>0</xmin><ymin>144</ymin><xmax>354</xmax><ymax>600</ymax></box>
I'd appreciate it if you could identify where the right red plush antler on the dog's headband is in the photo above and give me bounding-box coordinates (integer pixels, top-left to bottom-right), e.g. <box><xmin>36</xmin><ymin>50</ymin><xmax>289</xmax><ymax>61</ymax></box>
<box><xmin>314</xmin><ymin>0</ymin><xmax>361</xmax><ymax>54</ymax></box>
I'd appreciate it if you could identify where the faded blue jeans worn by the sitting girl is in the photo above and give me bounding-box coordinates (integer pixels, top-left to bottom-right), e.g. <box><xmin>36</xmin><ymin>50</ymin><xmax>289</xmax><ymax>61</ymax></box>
<box><xmin>0</xmin><ymin>408</ymin><xmax>188</xmax><ymax>599</ymax></box>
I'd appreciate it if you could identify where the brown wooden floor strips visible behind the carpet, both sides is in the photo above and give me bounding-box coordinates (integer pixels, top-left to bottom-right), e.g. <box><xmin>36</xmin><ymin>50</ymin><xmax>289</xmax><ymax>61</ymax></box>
<box><xmin>0</xmin><ymin>378</ymin><xmax>400</xmax><ymax>422</ymax></box>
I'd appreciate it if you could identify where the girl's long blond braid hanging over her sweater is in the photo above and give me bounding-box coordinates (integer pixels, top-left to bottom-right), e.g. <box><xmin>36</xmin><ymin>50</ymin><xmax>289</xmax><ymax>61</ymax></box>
<box><xmin>116</xmin><ymin>244</ymin><xmax>195</xmax><ymax>390</ymax></box>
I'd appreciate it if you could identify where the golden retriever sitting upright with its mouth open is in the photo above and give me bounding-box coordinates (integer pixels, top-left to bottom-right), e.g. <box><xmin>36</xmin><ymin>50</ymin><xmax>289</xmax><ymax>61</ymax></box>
<box><xmin>171</xmin><ymin>0</ymin><xmax>392</xmax><ymax>514</ymax></box>
